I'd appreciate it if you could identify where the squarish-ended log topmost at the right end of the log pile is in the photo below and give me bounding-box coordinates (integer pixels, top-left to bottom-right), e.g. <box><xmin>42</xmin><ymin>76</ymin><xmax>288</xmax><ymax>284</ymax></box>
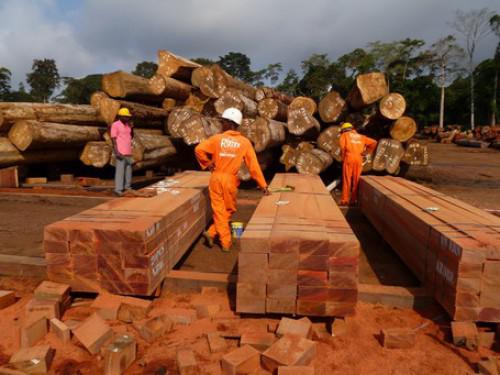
<box><xmin>347</xmin><ymin>72</ymin><xmax>389</xmax><ymax>110</ymax></box>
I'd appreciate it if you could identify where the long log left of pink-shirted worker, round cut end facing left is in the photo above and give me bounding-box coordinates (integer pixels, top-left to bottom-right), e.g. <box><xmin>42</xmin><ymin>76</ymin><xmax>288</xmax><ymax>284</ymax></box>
<box><xmin>9</xmin><ymin>120</ymin><xmax>106</xmax><ymax>151</ymax></box>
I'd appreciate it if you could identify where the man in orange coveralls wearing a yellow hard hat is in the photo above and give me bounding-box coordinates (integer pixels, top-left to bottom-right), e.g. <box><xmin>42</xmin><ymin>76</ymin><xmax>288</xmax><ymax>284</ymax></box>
<box><xmin>340</xmin><ymin>122</ymin><xmax>377</xmax><ymax>206</ymax></box>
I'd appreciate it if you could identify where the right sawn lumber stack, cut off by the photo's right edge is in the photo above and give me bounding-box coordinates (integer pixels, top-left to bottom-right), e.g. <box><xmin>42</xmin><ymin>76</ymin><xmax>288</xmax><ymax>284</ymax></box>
<box><xmin>360</xmin><ymin>176</ymin><xmax>500</xmax><ymax>323</ymax></box>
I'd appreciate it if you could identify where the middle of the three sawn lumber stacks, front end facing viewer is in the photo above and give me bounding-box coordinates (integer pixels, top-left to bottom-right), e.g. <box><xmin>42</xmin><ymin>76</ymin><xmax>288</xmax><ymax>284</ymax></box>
<box><xmin>236</xmin><ymin>174</ymin><xmax>360</xmax><ymax>316</ymax></box>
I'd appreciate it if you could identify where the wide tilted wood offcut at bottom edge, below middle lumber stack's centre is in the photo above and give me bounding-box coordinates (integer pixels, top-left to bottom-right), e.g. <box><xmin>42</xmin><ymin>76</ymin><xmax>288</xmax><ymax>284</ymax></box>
<box><xmin>262</xmin><ymin>335</ymin><xmax>316</xmax><ymax>372</ymax></box>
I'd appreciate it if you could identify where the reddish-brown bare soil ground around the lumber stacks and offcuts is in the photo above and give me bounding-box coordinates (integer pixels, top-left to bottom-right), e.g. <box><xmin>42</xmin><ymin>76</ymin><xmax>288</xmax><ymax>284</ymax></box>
<box><xmin>0</xmin><ymin>144</ymin><xmax>500</xmax><ymax>375</ymax></box>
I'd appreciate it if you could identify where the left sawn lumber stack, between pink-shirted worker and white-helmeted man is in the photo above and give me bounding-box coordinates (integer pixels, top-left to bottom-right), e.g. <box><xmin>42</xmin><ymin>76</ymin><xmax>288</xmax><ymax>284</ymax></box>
<box><xmin>43</xmin><ymin>172</ymin><xmax>210</xmax><ymax>295</ymax></box>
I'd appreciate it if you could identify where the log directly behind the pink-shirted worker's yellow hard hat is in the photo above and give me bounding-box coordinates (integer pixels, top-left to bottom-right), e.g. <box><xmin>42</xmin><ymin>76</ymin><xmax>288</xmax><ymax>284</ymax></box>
<box><xmin>90</xmin><ymin>91</ymin><xmax>169</xmax><ymax>128</ymax></box>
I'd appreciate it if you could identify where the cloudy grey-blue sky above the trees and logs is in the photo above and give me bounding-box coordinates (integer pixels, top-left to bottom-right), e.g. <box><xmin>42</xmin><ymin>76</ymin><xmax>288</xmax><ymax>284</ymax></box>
<box><xmin>0</xmin><ymin>0</ymin><xmax>500</xmax><ymax>85</ymax></box>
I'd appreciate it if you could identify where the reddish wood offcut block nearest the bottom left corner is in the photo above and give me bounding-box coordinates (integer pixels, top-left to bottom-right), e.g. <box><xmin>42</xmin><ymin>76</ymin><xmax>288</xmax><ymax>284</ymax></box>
<box><xmin>9</xmin><ymin>345</ymin><xmax>54</xmax><ymax>374</ymax></box>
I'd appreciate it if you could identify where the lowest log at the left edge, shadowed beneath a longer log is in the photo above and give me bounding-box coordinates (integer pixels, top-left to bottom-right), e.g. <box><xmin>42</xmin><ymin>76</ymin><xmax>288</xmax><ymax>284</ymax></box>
<box><xmin>0</xmin><ymin>137</ymin><xmax>80</xmax><ymax>166</ymax></box>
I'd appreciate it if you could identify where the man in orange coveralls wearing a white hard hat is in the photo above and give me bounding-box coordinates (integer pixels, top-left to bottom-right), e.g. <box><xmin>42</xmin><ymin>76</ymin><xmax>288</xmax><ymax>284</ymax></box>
<box><xmin>195</xmin><ymin>108</ymin><xmax>269</xmax><ymax>252</ymax></box>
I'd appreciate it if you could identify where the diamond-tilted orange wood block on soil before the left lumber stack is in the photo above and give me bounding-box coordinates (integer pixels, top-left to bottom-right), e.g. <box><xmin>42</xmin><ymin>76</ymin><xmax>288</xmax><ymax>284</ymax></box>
<box><xmin>73</xmin><ymin>314</ymin><xmax>113</xmax><ymax>354</ymax></box>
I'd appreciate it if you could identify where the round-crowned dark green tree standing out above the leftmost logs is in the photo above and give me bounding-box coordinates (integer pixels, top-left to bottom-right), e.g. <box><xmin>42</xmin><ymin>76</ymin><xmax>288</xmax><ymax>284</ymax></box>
<box><xmin>26</xmin><ymin>59</ymin><xmax>61</xmax><ymax>103</ymax></box>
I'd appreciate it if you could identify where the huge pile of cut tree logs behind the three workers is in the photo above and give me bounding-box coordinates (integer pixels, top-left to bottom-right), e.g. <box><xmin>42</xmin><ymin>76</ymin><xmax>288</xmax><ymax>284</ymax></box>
<box><xmin>0</xmin><ymin>51</ymin><xmax>427</xmax><ymax>179</ymax></box>
